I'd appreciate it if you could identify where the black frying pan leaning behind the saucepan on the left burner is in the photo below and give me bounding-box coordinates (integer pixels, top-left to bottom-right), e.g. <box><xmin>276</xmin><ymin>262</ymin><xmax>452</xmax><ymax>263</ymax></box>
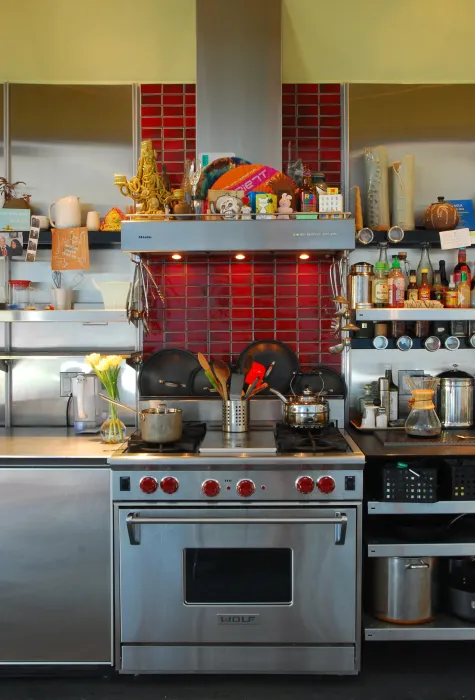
<box><xmin>139</xmin><ymin>348</ymin><xmax>200</xmax><ymax>396</ymax></box>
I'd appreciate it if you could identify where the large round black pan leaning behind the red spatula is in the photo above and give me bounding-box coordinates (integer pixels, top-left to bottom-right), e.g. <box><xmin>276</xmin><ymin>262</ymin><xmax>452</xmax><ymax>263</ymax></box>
<box><xmin>236</xmin><ymin>340</ymin><xmax>300</xmax><ymax>394</ymax></box>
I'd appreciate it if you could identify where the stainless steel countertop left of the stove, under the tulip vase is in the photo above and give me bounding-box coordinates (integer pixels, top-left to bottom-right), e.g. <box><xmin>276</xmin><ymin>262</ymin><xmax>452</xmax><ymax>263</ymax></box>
<box><xmin>0</xmin><ymin>428</ymin><xmax>117</xmax><ymax>466</ymax></box>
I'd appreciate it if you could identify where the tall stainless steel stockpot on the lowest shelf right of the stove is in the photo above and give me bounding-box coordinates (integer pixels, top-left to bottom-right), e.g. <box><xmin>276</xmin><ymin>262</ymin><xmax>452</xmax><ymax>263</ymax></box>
<box><xmin>373</xmin><ymin>557</ymin><xmax>437</xmax><ymax>625</ymax></box>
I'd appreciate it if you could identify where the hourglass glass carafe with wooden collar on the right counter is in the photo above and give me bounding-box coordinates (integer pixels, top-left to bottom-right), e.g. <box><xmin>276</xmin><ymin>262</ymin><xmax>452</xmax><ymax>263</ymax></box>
<box><xmin>404</xmin><ymin>377</ymin><xmax>442</xmax><ymax>437</ymax></box>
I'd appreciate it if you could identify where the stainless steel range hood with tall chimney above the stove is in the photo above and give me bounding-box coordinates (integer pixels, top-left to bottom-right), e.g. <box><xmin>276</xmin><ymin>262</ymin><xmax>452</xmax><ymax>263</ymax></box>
<box><xmin>122</xmin><ymin>0</ymin><xmax>355</xmax><ymax>253</ymax></box>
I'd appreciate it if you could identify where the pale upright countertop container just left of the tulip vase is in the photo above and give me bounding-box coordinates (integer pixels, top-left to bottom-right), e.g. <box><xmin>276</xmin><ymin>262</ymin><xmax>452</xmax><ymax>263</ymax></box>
<box><xmin>71</xmin><ymin>372</ymin><xmax>106</xmax><ymax>433</ymax></box>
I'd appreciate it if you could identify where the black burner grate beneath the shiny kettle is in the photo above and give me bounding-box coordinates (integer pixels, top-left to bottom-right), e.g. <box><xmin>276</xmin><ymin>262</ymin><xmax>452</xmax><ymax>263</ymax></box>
<box><xmin>275</xmin><ymin>423</ymin><xmax>350</xmax><ymax>454</ymax></box>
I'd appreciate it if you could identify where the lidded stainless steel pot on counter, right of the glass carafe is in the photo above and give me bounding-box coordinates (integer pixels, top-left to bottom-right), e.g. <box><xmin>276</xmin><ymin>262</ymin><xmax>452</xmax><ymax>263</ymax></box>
<box><xmin>437</xmin><ymin>365</ymin><xmax>474</xmax><ymax>428</ymax></box>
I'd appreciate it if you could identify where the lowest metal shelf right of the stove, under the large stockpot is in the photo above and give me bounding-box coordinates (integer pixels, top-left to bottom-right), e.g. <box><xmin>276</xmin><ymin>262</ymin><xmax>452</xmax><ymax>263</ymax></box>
<box><xmin>363</xmin><ymin>613</ymin><xmax>475</xmax><ymax>642</ymax></box>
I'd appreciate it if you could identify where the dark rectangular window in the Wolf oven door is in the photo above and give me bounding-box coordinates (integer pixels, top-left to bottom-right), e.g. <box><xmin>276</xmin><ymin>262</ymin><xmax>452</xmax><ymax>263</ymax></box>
<box><xmin>184</xmin><ymin>548</ymin><xmax>292</xmax><ymax>605</ymax></box>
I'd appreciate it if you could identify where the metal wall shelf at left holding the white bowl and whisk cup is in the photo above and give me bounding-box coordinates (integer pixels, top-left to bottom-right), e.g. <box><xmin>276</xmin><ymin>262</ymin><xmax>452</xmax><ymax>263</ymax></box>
<box><xmin>0</xmin><ymin>309</ymin><xmax>127</xmax><ymax>325</ymax></box>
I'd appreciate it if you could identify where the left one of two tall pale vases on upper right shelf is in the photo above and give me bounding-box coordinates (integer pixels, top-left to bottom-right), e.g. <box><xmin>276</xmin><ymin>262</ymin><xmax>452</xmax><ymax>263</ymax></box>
<box><xmin>364</xmin><ymin>146</ymin><xmax>389</xmax><ymax>231</ymax></box>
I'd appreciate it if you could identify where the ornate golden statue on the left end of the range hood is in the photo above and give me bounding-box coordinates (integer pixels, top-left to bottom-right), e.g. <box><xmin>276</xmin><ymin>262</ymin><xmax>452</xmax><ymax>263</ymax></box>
<box><xmin>114</xmin><ymin>141</ymin><xmax>170</xmax><ymax>214</ymax></box>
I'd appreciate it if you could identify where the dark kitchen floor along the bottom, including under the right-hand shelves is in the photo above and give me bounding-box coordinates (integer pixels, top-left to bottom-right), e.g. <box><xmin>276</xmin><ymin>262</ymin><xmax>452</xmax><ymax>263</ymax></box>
<box><xmin>0</xmin><ymin>642</ymin><xmax>475</xmax><ymax>700</ymax></box>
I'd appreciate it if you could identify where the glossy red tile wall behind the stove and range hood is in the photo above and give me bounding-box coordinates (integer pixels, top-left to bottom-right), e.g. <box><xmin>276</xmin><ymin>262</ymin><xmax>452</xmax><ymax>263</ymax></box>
<box><xmin>141</xmin><ymin>84</ymin><xmax>341</xmax><ymax>368</ymax></box>
